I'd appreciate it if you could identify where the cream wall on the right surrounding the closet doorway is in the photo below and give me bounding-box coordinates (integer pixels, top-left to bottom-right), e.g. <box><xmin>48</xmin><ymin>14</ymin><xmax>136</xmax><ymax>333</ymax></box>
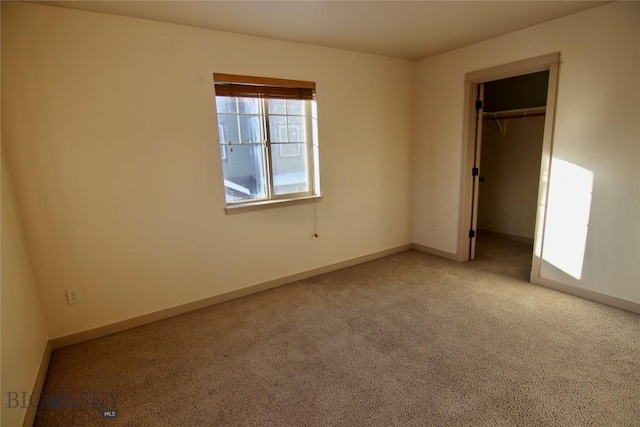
<box><xmin>413</xmin><ymin>2</ymin><xmax>640</xmax><ymax>302</ymax></box>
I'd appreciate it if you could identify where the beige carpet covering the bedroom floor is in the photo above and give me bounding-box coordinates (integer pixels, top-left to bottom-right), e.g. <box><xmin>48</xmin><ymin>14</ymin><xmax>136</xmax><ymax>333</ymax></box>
<box><xmin>36</xmin><ymin>241</ymin><xmax>640</xmax><ymax>426</ymax></box>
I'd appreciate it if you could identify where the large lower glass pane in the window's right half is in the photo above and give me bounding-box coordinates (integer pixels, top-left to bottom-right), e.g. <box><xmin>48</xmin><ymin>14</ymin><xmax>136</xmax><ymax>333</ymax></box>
<box><xmin>271</xmin><ymin>144</ymin><xmax>309</xmax><ymax>195</ymax></box>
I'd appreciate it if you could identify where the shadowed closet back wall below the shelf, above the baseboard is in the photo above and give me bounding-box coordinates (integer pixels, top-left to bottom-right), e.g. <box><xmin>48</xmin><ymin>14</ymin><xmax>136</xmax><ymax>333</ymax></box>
<box><xmin>478</xmin><ymin>116</ymin><xmax>545</xmax><ymax>242</ymax></box>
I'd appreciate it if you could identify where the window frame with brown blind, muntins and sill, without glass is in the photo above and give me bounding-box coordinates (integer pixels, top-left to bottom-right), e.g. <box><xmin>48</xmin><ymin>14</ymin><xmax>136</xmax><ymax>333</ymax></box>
<box><xmin>214</xmin><ymin>73</ymin><xmax>321</xmax><ymax>213</ymax></box>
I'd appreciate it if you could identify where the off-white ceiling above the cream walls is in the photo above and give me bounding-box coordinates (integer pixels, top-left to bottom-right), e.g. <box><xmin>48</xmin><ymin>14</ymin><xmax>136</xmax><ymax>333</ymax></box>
<box><xmin>28</xmin><ymin>0</ymin><xmax>608</xmax><ymax>60</ymax></box>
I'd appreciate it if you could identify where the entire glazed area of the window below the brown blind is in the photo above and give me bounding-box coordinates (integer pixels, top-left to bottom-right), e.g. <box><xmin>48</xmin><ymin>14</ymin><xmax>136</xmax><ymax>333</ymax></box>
<box><xmin>216</xmin><ymin>90</ymin><xmax>319</xmax><ymax>203</ymax></box>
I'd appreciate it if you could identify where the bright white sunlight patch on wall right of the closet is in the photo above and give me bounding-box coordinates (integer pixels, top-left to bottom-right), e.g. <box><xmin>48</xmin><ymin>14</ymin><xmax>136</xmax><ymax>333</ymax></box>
<box><xmin>542</xmin><ymin>158</ymin><xmax>593</xmax><ymax>279</ymax></box>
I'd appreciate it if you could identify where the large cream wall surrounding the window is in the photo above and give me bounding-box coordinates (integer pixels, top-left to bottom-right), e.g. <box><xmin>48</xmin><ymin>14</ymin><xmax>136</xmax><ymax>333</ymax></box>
<box><xmin>2</xmin><ymin>3</ymin><xmax>414</xmax><ymax>338</ymax></box>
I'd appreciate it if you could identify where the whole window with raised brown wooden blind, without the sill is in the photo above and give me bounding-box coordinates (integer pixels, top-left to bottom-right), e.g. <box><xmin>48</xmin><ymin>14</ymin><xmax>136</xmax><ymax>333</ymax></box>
<box><xmin>214</xmin><ymin>74</ymin><xmax>319</xmax><ymax>206</ymax></box>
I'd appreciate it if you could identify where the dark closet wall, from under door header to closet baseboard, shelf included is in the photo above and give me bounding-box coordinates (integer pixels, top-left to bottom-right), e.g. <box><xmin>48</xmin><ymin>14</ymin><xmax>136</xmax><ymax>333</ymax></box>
<box><xmin>477</xmin><ymin>71</ymin><xmax>549</xmax><ymax>243</ymax></box>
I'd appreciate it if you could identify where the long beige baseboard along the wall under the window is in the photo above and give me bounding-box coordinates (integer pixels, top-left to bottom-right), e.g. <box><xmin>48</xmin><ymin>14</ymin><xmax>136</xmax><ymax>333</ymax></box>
<box><xmin>50</xmin><ymin>244</ymin><xmax>412</xmax><ymax>350</ymax></box>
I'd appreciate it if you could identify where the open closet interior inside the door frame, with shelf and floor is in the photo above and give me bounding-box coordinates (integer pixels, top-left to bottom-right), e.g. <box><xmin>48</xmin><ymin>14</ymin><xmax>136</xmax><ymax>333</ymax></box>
<box><xmin>470</xmin><ymin>70</ymin><xmax>549</xmax><ymax>280</ymax></box>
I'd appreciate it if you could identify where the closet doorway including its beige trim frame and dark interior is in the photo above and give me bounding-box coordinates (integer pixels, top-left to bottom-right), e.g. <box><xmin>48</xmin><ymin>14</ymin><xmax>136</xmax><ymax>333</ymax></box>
<box><xmin>458</xmin><ymin>54</ymin><xmax>559</xmax><ymax>283</ymax></box>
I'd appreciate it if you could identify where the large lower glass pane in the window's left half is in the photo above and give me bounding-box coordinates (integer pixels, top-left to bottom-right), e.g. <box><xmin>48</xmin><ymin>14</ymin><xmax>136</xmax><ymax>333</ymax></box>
<box><xmin>222</xmin><ymin>144</ymin><xmax>267</xmax><ymax>203</ymax></box>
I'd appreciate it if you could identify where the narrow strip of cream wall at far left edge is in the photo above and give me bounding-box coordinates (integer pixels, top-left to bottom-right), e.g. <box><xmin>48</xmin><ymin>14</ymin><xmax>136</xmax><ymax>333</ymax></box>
<box><xmin>0</xmin><ymin>145</ymin><xmax>48</xmax><ymax>426</ymax></box>
